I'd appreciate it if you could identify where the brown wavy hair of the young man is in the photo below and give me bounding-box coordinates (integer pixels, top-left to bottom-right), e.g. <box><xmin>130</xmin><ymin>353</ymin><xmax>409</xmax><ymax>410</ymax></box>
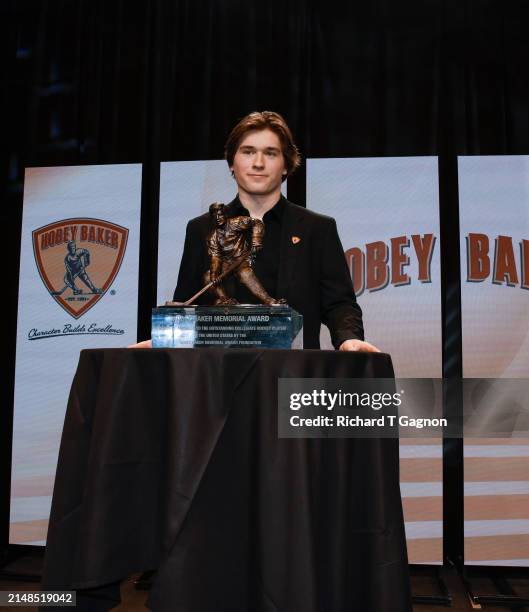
<box><xmin>224</xmin><ymin>111</ymin><xmax>301</xmax><ymax>180</ymax></box>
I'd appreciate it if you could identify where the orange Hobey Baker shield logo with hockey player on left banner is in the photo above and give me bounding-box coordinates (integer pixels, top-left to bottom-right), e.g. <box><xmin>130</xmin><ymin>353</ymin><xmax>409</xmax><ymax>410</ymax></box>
<box><xmin>33</xmin><ymin>218</ymin><xmax>129</xmax><ymax>319</ymax></box>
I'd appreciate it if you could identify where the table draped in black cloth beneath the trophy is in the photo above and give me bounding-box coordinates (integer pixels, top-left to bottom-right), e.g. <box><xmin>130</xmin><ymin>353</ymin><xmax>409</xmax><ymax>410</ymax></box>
<box><xmin>43</xmin><ymin>349</ymin><xmax>411</xmax><ymax>612</ymax></box>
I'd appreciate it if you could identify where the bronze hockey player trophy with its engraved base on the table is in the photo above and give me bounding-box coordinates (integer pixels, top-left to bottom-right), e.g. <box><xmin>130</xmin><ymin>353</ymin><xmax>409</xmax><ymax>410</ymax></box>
<box><xmin>152</xmin><ymin>202</ymin><xmax>303</xmax><ymax>348</ymax></box>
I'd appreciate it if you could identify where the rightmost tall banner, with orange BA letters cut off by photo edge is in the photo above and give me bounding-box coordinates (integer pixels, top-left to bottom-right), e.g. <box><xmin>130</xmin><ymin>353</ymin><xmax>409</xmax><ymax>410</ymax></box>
<box><xmin>458</xmin><ymin>156</ymin><xmax>529</xmax><ymax>566</ymax></box>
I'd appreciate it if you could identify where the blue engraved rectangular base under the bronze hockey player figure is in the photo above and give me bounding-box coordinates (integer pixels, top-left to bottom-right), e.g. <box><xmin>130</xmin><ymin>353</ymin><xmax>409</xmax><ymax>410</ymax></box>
<box><xmin>151</xmin><ymin>304</ymin><xmax>303</xmax><ymax>349</ymax></box>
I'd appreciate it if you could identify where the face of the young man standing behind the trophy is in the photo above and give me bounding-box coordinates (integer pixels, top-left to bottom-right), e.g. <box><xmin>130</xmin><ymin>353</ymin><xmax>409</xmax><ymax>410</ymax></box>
<box><xmin>231</xmin><ymin>129</ymin><xmax>287</xmax><ymax>195</ymax></box>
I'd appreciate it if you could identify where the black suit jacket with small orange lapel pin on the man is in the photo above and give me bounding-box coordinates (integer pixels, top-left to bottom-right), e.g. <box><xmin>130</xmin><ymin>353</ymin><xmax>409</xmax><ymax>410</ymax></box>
<box><xmin>174</xmin><ymin>200</ymin><xmax>364</xmax><ymax>348</ymax></box>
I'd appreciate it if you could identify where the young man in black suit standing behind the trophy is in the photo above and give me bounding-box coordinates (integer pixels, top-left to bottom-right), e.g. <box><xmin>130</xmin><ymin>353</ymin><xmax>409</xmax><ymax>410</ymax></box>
<box><xmin>174</xmin><ymin>111</ymin><xmax>378</xmax><ymax>352</ymax></box>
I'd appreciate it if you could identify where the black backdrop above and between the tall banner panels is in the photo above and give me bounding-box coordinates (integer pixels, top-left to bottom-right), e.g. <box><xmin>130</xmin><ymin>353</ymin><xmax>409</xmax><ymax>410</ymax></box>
<box><xmin>0</xmin><ymin>0</ymin><xmax>529</xmax><ymax>558</ymax></box>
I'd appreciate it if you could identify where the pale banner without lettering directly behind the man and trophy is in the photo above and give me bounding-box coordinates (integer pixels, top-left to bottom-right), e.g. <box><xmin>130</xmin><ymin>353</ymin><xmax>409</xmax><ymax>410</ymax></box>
<box><xmin>157</xmin><ymin>160</ymin><xmax>286</xmax><ymax>304</ymax></box>
